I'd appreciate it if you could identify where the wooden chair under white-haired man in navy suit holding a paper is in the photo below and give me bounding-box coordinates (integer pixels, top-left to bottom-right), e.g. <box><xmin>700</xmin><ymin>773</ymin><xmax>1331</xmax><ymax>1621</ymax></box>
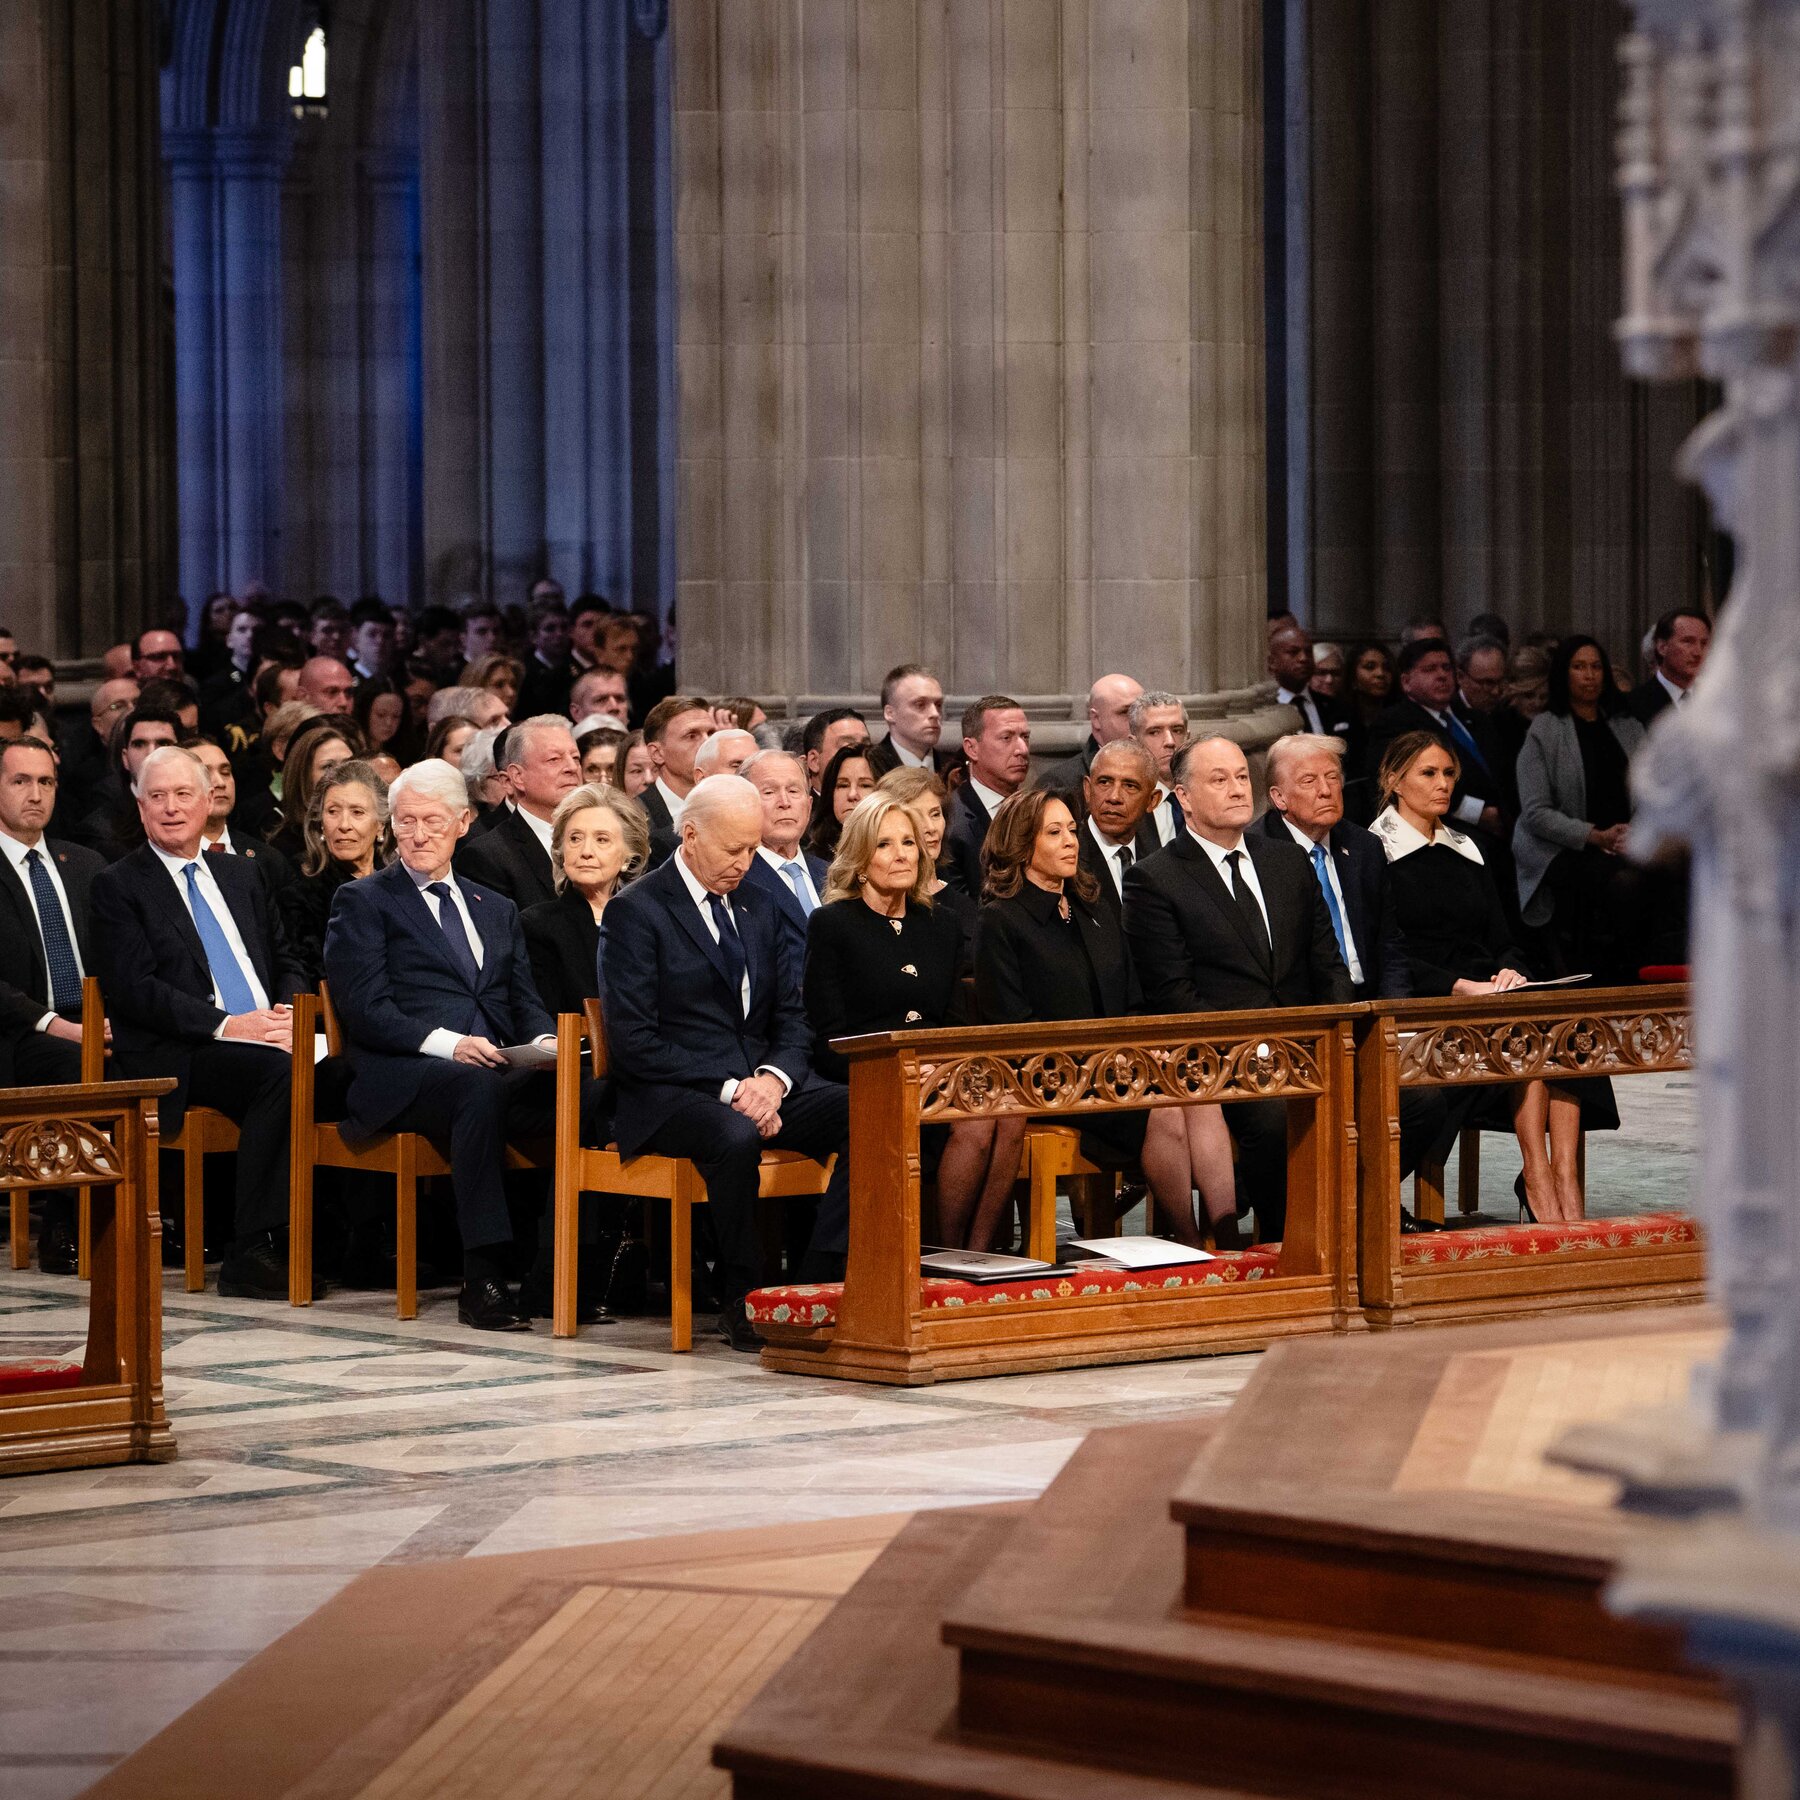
<box><xmin>288</xmin><ymin>981</ymin><xmax>549</xmax><ymax>1319</ymax></box>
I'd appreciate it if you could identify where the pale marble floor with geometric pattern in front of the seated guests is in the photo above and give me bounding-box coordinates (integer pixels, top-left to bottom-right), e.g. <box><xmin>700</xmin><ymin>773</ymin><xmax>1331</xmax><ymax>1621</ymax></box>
<box><xmin>0</xmin><ymin>1076</ymin><xmax>1697</xmax><ymax>1800</ymax></box>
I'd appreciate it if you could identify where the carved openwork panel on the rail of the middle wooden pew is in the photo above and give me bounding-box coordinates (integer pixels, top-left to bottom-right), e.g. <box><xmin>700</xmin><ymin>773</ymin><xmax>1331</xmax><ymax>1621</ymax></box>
<box><xmin>918</xmin><ymin>1037</ymin><xmax>1325</xmax><ymax>1123</ymax></box>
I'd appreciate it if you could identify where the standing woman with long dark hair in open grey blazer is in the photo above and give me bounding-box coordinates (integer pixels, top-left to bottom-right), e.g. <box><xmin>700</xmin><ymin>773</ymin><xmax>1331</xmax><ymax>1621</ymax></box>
<box><xmin>1512</xmin><ymin>637</ymin><xmax>1648</xmax><ymax>985</ymax></box>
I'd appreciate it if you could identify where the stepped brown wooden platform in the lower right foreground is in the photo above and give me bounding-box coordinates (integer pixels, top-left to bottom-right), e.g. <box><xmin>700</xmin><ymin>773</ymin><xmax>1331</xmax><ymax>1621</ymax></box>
<box><xmin>716</xmin><ymin>1319</ymin><xmax>1737</xmax><ymax>1800</ymax></box>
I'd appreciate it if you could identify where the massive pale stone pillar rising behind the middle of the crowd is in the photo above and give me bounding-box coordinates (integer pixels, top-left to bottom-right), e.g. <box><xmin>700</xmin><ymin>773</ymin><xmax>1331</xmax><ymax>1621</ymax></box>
<box><xmin>673</xmin><ymin>0</ymin><xmax>1265</xmax><ymax>718</ymax></box>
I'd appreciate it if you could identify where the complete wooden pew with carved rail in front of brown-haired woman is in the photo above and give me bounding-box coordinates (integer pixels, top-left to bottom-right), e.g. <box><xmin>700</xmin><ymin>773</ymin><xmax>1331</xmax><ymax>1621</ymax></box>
<box><xmin>761</xmin><ymin>1006</ymin><xmax>1363</xmax><ymax>1386</ymax></box>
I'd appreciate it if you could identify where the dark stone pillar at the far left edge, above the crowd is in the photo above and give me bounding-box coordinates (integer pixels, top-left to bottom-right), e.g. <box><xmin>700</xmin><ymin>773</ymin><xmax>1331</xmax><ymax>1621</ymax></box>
<box><xmin>0</xmin><ymin>0</ymin><xmax>173</xmax><ymax>659</ymax></box>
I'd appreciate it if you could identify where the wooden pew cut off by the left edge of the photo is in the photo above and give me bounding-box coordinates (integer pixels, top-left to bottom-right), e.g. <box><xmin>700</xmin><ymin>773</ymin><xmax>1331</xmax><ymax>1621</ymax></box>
<box><xmin>0</xmin><ymin>1080</ymin><xmax>175</xmax><ymax>1474</ymax></box>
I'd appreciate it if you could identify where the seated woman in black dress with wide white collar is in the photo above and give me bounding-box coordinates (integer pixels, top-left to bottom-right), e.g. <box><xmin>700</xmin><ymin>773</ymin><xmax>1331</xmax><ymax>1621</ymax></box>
<box><xmin>1370</xmin><ymin>731</ymin><xmax>1618</xmax><ymax>1220</ymax></box>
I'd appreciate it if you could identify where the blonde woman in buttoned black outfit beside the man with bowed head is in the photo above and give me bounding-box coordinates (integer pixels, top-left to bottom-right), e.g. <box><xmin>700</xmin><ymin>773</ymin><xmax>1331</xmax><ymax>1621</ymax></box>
<box><xmin>805</xmin><ymin>794</ymin><xmax>1024</xmax><ymax>1249</ymax></box>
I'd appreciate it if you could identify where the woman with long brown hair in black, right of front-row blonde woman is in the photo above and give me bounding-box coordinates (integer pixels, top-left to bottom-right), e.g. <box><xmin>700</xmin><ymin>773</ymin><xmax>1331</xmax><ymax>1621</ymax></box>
<box><xmin>976</xmin><ymin>788</ymin><xmax>1237</xmax><ymax>1247</ymax></box>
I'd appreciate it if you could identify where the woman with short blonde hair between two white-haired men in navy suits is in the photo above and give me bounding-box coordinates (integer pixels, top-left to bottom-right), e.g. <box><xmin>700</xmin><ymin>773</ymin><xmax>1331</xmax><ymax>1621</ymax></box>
<box><xmin>520</xmin><ymin>785</ymin><xmax>650</xmax><ymax>1015</ymax></box>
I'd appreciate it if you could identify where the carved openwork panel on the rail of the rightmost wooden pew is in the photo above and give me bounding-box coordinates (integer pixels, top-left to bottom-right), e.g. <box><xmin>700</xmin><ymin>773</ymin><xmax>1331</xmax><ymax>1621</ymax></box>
<box><xmin>1400</xmin><ymin>1012</ymin><xmax>1694</xmax><ymax>1087</ymax></box>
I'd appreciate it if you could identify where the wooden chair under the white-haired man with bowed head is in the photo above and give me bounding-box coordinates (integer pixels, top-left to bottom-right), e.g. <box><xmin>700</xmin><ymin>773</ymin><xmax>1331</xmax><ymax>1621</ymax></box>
<box><xmin>553</xmin><ymin>1001</ymin><xmax>837</xmax><ymax>1350</ymax></box>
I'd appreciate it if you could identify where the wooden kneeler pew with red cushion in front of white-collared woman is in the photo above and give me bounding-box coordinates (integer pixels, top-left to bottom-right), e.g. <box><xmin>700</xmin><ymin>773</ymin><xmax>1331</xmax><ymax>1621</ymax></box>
<box><xmin>1355</xmin><ymin>985</ymin><xmax>1705</xmax><ymax>1328</ymax></box>
